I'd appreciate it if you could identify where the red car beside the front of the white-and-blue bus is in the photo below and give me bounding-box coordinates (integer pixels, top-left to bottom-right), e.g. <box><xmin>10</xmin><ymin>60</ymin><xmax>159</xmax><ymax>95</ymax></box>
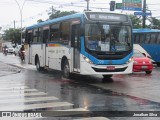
<box><xmin>133</xmin><ymin>49</ymin><xmax>153</xmax><ymax>74</ymax></box>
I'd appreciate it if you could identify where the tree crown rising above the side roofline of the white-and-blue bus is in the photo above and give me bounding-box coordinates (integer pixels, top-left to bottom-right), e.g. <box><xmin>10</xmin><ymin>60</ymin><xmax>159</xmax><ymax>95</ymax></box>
<box><xmin>48</xmin><ymin>9</ymin><xmax>76</xmax><ymax>19</ymax></box>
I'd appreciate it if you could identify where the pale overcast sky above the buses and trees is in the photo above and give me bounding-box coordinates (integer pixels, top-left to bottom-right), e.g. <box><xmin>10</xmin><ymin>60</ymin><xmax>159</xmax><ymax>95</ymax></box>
<box><xmin>0</xmin><ymin>0</ymin><xmax>160</xmax><ymax>32</ymax></box>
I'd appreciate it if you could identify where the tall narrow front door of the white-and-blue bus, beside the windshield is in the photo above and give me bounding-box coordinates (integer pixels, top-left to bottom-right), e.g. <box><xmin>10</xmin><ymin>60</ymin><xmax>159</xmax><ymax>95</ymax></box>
<box><xmin>71</xmin><ymin>24</ymin><xmax>80</xmax><ymax>72</ymax></box>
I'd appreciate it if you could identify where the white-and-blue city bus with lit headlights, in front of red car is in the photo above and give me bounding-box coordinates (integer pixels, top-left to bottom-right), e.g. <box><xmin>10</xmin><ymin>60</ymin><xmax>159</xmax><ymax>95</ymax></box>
<box><xmin>25</xmin><ymin>12</ymin><xmax>133</xmax><ymax>78</ymax></box>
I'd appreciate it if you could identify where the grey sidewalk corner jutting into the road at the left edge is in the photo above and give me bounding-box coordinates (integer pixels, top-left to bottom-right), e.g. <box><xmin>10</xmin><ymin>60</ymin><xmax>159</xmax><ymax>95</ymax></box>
<box><xmin>0</xmin><ymin>62</ymin><xmax>21</xmax><ymax>77</ymax></box>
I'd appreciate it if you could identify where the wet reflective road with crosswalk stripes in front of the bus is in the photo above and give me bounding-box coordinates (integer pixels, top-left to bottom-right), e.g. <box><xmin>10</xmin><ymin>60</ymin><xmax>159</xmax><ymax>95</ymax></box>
<box><xmin>0</xmin><ymin>53</ymin><xmax>160</xmax><ymax>120</ymax></box>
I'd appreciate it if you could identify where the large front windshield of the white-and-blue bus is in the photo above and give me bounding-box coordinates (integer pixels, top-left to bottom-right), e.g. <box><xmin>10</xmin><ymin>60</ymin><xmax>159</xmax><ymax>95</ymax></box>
<box><xmin>85</xmin><ymin>23</ymin><xmax>132</xmax><ymax>52</ymax></box>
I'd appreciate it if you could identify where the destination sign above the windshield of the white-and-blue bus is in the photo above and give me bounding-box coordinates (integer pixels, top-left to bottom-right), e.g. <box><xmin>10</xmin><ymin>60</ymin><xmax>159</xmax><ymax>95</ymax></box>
<box><xmin>87</xmin><ymin>13</ymin><xmax>127</xmax><ymax>22</ymax></box>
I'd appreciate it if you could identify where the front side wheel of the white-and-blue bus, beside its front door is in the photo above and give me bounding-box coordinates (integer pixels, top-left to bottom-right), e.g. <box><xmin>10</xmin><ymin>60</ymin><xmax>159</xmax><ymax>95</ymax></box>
<box><xmin>63</xmin><ymin>60</ymin><xmax>70</xmax><ymax>78</ymax></box>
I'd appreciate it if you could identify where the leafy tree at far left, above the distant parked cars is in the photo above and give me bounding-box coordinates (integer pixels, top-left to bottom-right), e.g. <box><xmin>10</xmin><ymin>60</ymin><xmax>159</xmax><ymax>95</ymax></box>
<box><xmin>3</xmin><ymin>28</ymin><xmax>21</xmax><ymax>44</ymax></box>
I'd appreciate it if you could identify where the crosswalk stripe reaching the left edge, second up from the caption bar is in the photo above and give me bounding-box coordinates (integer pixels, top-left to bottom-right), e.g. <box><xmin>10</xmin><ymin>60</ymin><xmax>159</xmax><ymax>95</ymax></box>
<box><xmin>0</xmin><ymin>96</ymin><xmax>58</xmax><ymax>106</ymax></box>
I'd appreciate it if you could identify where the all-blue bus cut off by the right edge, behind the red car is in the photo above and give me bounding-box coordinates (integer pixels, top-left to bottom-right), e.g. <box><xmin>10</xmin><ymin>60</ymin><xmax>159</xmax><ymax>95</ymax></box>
<box><xmin>133</xmin><ymin>29</ymin><xmax>160</xmax><ymax>66</ymax></box>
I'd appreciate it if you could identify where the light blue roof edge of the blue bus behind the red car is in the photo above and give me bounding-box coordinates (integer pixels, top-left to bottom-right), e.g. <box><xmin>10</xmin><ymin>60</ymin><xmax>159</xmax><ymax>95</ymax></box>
<box><xmin>133</xmin><ymin>28</ymin><xmax>160</xmax><ymax>33</ymax></box>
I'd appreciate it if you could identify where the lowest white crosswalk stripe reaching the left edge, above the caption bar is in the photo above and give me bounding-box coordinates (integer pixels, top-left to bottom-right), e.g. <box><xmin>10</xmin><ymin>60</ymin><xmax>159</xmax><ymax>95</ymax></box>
<box><xmin>0</xmin><ymin>102</ymin><xmax>73</xmax><ymax>111</ymax></box>
